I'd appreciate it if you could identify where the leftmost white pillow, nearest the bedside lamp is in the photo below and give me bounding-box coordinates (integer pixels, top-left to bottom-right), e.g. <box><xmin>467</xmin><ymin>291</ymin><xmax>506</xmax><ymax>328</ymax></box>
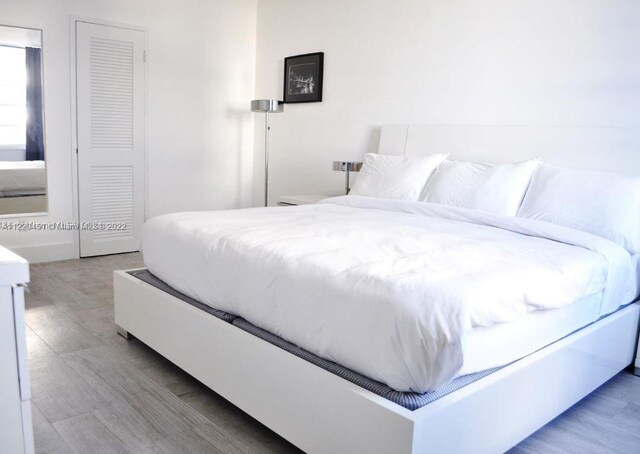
<box><xmin>350</xmin><ymin>153</ymin><xmax>447</xmax><ymax>200</ymax></box>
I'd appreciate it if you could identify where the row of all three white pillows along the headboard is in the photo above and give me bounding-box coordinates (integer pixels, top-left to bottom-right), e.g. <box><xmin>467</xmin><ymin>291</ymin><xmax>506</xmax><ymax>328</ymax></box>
<box><xmin>351</xmin><ymin>153</ymin><xmax>640</xmax><ymax>253</ymax></box>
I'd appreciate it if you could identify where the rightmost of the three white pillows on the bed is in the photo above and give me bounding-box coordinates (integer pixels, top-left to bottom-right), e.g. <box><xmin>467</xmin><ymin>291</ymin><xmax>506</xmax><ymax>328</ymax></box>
<box><xmin>518</xmin><ymin>165</ymin><xmax>640</xmax><ymax>253</ymax></box>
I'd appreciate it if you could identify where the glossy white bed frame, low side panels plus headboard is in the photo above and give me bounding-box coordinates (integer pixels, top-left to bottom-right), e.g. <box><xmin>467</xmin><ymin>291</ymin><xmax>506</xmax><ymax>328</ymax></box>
<box><xmin>114</xmin><ymin>125</ymin><xmax>640</xmax><ymax>453</ymax></box>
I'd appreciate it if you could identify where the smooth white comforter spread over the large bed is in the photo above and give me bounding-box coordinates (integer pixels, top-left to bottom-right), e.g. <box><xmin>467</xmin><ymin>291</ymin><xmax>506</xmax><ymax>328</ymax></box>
<box><xmin>142</xmin><ymin>196</ymin><xmax>635</xmax><ymax>392</ymax></box>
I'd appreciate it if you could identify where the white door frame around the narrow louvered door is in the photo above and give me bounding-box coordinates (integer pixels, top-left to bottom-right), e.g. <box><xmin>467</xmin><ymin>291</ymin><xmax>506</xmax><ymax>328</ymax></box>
<box><xmin>69</xmin><ymin>15</ymin><xmax>149</xmax><ymax>258</ymax></box>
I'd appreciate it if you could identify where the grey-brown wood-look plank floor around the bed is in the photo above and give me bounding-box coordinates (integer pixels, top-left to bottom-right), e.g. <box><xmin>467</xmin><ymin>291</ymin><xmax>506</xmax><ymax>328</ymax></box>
<box><xmin>25</xmin><ymin>254</ymin><xmax>640</xmax><ymax>454</ymax></box>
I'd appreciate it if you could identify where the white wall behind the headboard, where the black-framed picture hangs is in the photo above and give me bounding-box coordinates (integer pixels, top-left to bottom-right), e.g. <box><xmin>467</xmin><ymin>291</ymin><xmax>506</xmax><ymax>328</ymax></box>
<box><xmin>254</xmin><ymin>0</ymin><xmax>640</xmax><ymax>205</ymax></box>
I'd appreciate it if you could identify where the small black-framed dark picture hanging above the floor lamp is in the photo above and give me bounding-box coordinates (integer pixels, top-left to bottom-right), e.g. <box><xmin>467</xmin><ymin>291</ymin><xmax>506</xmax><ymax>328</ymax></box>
<box><xmin>283</xmin><ymin>52</ymin><xmax>324</xmax><ymax>103</ymax></box>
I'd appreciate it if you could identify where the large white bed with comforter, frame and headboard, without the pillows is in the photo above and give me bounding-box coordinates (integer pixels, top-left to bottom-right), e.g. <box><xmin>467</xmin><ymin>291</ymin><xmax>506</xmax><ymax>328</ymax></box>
<box><xmin>115</xmin><ymin>126</ymin><xmax>640</xmax><ymax>452</ymax></box>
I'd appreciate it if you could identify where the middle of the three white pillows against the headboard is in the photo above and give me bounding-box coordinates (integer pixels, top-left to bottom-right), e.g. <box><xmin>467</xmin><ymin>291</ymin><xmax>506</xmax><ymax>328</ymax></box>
<box><xmin>421</xmin><ymin>159</ymin><xmax>538</xmax><ymax>216</ymax></box>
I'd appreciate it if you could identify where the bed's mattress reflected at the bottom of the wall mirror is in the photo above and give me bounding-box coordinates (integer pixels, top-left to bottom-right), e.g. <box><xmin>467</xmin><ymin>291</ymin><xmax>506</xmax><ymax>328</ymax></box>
<box><xmin>0</xmin><ymin>161</ymin><xmax>46</xmax><ymax>197</ymax></box>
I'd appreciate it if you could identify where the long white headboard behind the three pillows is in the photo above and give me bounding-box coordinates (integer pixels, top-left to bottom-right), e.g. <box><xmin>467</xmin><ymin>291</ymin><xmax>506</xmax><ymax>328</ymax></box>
<box><xmin>378</xmin><ymin>125</ymin><xmax>640</xmax><ymax>177</ymax></box>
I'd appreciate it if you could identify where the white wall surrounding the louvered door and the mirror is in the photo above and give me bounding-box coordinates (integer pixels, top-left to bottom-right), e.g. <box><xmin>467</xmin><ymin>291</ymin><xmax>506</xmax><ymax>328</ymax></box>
<box><xmin>0</xmin><ymin>0</ymin><xmax>257</xmax><ymax>261</ymax></box>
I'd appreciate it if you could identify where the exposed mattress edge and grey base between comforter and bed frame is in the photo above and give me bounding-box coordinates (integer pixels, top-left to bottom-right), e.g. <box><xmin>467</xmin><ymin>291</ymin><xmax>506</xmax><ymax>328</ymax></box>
<box><xmin>129</xmin><ymin>269</ymin><xmax>636</xmax><ymax>411</ymax></box>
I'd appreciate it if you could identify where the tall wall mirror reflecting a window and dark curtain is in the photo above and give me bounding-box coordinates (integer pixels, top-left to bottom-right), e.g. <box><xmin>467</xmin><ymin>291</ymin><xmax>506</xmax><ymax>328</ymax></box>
<box><xmin>0</xmin><ymin>25</ymin><xmax>47</xmax><ymax>215</ymax></box>
